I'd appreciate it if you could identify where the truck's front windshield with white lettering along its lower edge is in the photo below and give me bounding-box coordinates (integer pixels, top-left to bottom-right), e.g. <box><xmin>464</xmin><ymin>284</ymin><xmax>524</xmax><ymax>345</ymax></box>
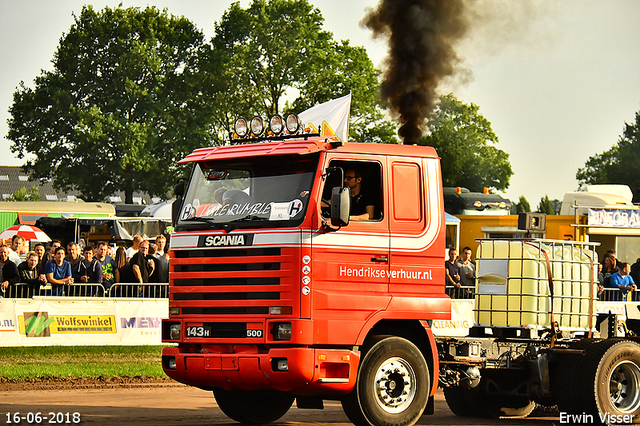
<box><xmin>179</xmin><ymin>155</ymin><xmax>318</xmax><ymax>228</ymax></box>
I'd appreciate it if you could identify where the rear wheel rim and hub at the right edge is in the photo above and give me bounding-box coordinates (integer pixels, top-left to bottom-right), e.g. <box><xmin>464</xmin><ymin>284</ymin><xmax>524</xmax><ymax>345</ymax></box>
<box><xmin>609</xmin><ymin>361</ymin><xmax>640</xmax><ymax>413</ymax></box>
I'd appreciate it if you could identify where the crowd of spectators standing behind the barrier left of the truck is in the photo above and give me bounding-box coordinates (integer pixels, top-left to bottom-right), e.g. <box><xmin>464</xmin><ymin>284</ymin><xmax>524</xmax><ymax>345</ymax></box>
<box><xmin>0</xmin><ymin>235</ymin><xmax>169</xmax><ymax>297</ymax></box>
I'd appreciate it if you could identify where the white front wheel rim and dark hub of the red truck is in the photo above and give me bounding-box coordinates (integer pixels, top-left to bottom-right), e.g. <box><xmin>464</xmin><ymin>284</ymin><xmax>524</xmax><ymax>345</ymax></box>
<box><xmin>375</xmin><ymin>357</ymin><xmax>416</xmax><ymax>413</ymax></box>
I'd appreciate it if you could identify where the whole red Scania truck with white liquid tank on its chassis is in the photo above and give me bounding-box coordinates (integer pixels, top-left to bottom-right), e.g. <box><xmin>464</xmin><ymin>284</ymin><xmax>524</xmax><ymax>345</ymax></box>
<box><xmin>162</xmin><ymin>113</ymin><xmax>640</xmax><ymax>426</ymax></box>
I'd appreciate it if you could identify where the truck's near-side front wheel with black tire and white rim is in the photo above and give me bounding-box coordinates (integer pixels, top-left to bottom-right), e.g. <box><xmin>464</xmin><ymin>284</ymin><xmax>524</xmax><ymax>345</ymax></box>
<box><xmin>342</xmin><ymin>337</ymin><xmax>431</xmax><ymax>426</ymax></box>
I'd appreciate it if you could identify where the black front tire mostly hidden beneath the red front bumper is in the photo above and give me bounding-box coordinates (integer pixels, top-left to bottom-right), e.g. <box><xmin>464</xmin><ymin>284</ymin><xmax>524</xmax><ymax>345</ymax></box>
<box><xmin>213</xmin><ymin>389</ymin><xmax>295</xmax><ymax>424</ymax></box>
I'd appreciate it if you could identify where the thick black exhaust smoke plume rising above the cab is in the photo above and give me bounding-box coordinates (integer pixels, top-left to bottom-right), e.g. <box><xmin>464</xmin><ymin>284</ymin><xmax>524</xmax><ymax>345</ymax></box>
<box><xmin>363</xmin><ymin>0</ymin><xmax>467</xmax><ymax>145</ymax></box>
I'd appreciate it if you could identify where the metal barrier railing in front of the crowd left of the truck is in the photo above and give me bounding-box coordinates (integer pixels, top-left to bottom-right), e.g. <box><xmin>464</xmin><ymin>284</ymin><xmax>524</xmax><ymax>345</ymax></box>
<box><xmin>0</xmin><ymin>283</ymin><xmax>169</xmax><ymax>299</ymax></box>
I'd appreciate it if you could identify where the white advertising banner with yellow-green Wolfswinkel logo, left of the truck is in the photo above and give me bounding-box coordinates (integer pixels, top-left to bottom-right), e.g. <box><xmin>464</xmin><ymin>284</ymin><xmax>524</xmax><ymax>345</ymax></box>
<box><xmin>0</xmin><ymin>298</ymin><xmax>169</xmax><ymax>346</ymax></box>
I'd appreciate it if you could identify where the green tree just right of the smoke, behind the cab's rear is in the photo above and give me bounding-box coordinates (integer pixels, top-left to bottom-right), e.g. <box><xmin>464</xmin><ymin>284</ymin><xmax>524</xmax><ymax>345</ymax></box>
<box><xmin>420</xmin><ymin>94</ymin><xmax>513</xmax><ymax>192</ymax></box>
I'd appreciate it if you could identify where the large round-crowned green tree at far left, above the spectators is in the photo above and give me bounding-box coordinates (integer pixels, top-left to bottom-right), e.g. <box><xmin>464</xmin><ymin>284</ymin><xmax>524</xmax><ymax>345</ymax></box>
<box><xmin>8</xmin><ymin>6</ymin><xmax>219</xmax><ymax>203</ymax></box>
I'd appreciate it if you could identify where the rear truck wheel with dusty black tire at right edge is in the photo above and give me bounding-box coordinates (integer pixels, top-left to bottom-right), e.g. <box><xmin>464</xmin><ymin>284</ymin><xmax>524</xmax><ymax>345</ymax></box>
<box><xmin>575</xmin><ymin>340</ymin><xmax>640</xmax><ymax>424</ymax></box>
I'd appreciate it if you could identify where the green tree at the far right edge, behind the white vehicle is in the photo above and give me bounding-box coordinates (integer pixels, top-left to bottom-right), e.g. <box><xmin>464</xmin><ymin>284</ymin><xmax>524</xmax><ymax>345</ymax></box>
<box><xmin>576</xmin><ymin>111</ymin><xmax>640</xmax><ymax>189</ymax></box>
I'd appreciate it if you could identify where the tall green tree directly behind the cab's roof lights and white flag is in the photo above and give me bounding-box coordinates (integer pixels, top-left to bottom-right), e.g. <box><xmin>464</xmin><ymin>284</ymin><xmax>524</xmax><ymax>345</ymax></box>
<box><xmin>212</xmin><ymin>0</ymin><xmax>390</xmax><ymax>142</ymax></box>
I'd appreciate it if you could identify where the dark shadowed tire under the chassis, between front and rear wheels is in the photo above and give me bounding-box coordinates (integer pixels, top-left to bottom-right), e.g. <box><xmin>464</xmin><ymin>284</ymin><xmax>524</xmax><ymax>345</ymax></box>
<box><xmin>443</xmin><ymin>383</ymin><xmax>536</xmax><ymax>418</ymax></box>
